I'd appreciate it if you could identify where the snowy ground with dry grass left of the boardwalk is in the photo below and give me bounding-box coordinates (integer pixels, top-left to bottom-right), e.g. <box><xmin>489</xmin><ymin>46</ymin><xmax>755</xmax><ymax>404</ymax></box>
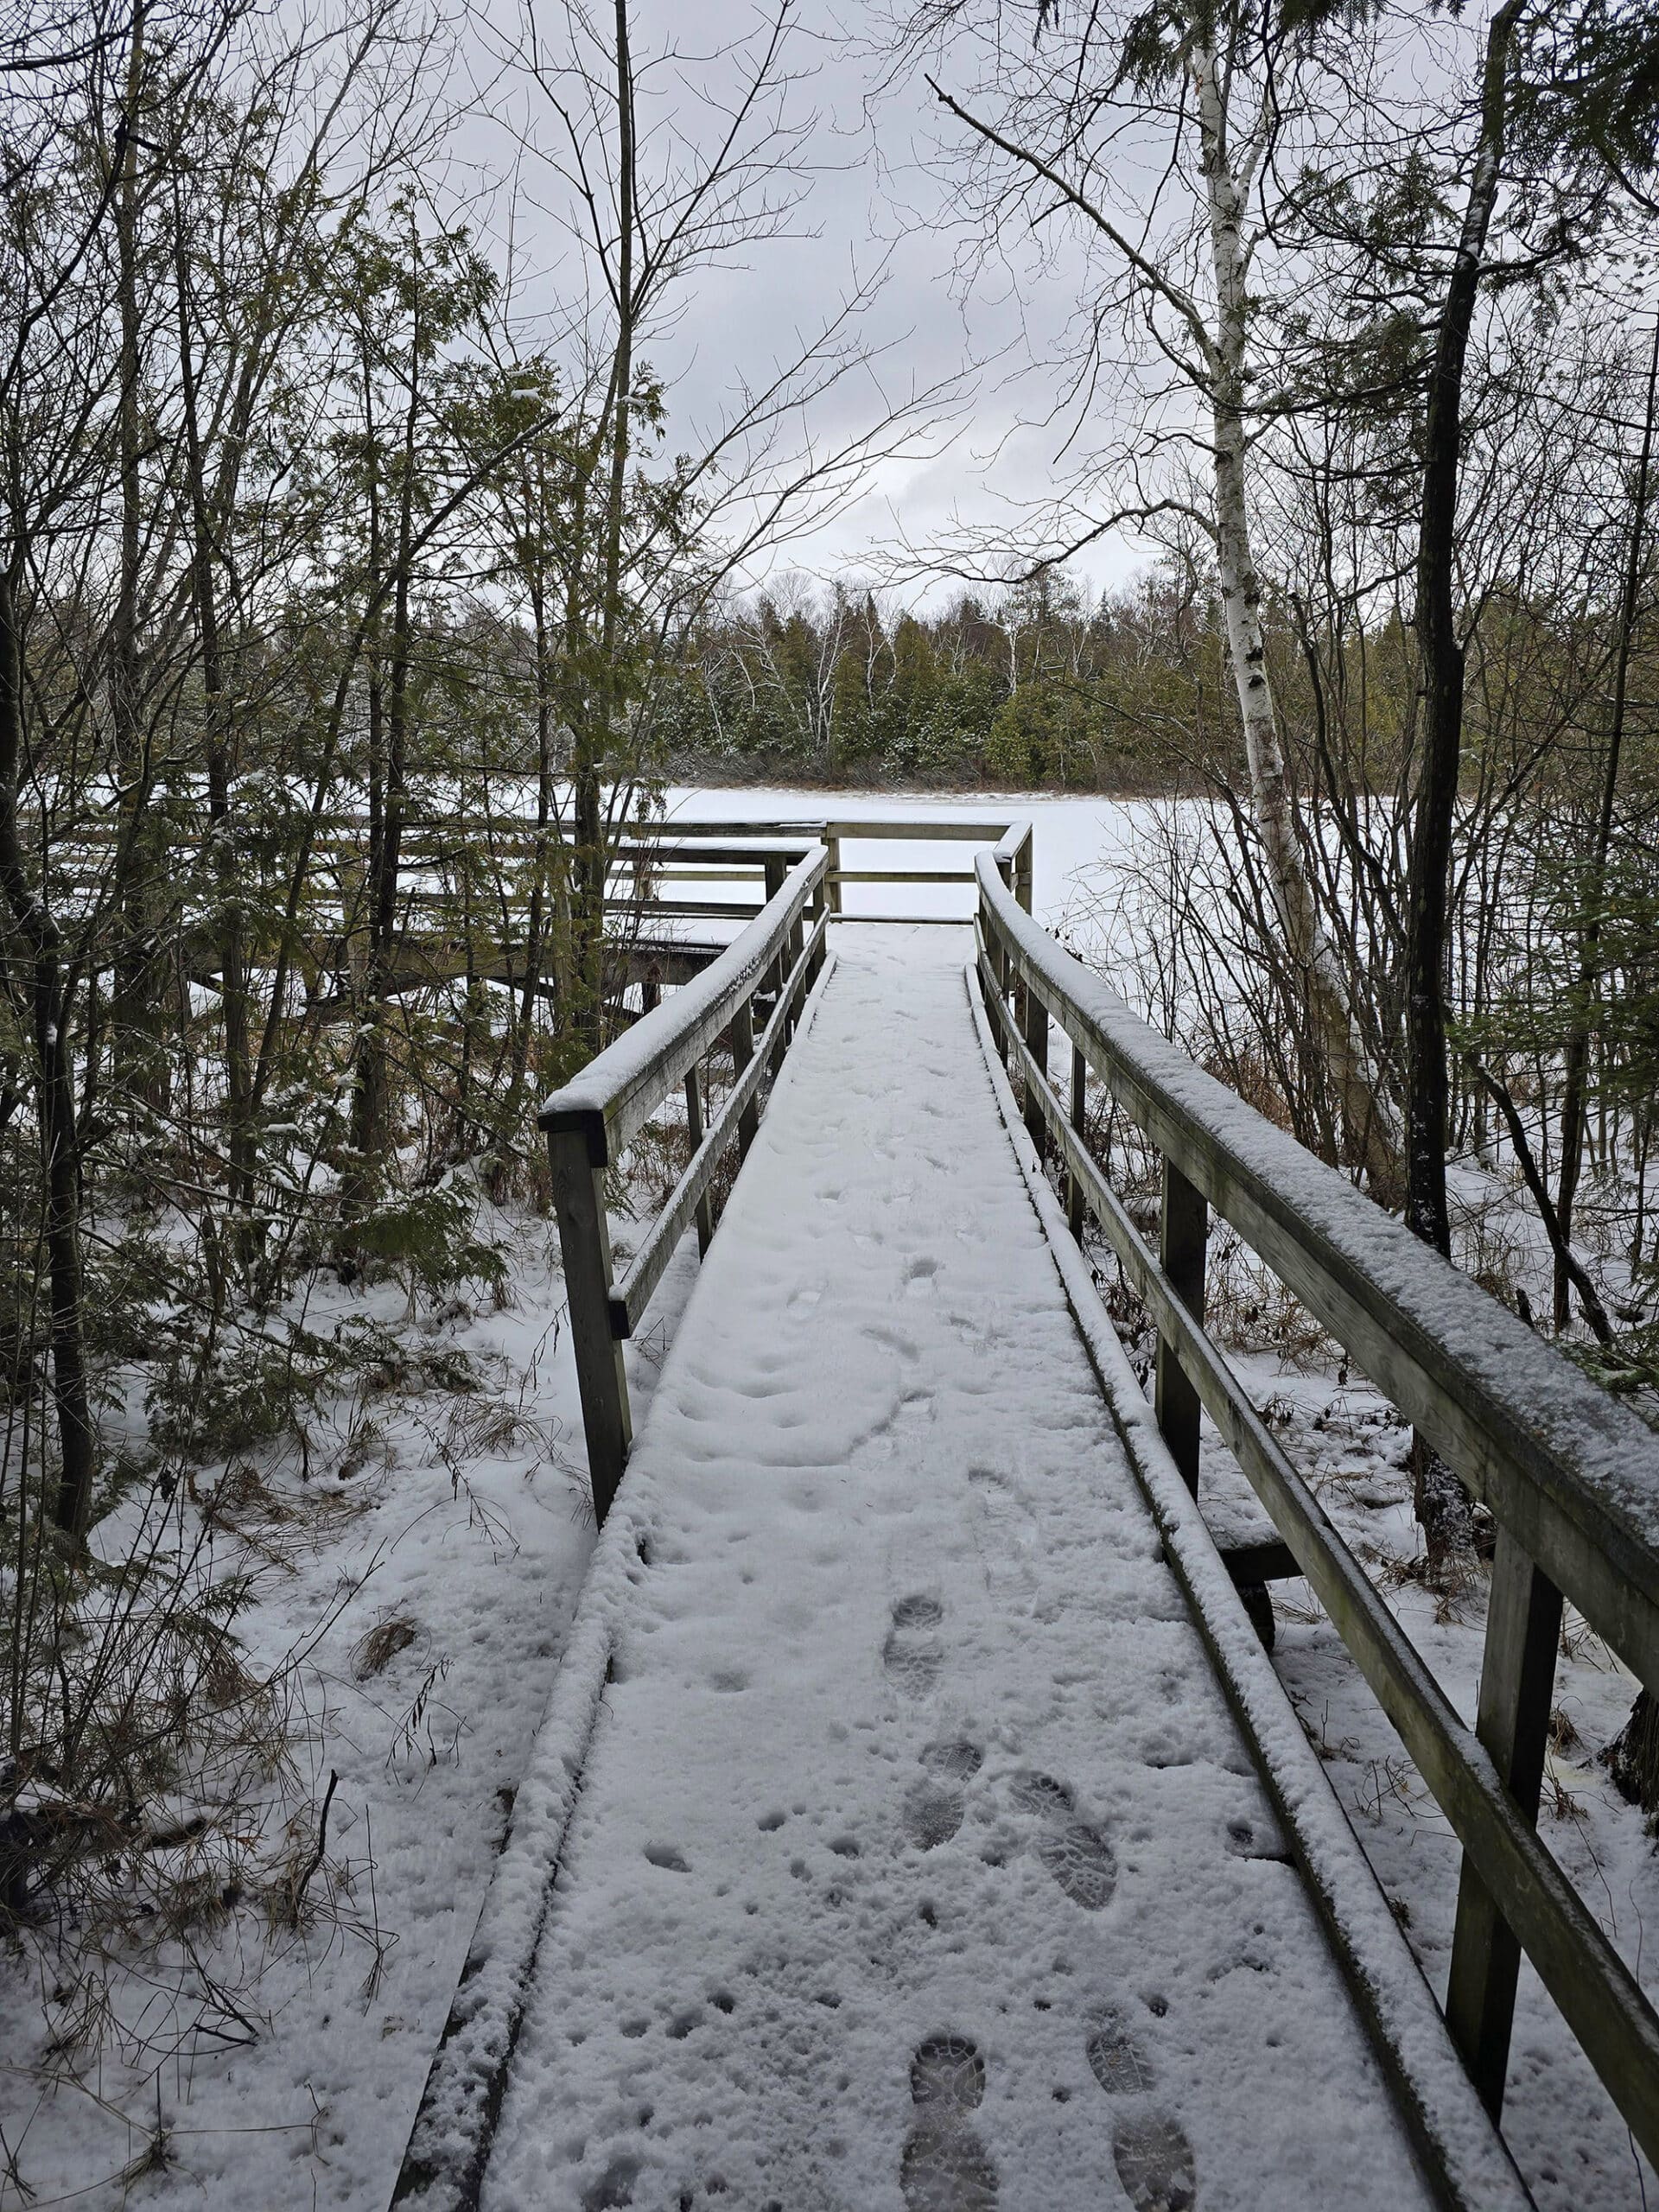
<box><xmin>0</xmin><ymin>1221</ymin><xmax>695</xmax><ymax>2212</ymax></box>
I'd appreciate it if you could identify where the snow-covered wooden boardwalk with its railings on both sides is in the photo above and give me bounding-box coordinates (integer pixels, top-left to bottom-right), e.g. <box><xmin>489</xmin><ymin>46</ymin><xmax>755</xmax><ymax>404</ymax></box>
<box><xmin>398</xmin><ymin>825</ymin><xmax>1659</xmax><ymax>2212</ymax></box>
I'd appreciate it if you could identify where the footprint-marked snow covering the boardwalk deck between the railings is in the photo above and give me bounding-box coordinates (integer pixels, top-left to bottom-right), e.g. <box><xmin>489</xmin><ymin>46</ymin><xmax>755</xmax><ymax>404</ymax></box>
<box><xmin>482</xmin><ymin>929</ymin><xmax>1427</xmax><ymax>2212</ymax></box>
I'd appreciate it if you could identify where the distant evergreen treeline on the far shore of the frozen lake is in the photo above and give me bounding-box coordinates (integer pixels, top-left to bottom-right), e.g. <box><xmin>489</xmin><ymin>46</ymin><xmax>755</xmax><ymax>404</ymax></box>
<box><xmin>641</xmin><ymin>560</ymin><xmax>1659</xmax><ymax>797</ymax></box>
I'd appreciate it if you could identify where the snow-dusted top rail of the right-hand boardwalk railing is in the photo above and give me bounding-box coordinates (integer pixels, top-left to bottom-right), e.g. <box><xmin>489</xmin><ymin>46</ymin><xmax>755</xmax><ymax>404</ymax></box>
<box><xmin>976</xmin><ymin>854</ymin><xmax>1659</xmax><ymax>1686</ymax></box>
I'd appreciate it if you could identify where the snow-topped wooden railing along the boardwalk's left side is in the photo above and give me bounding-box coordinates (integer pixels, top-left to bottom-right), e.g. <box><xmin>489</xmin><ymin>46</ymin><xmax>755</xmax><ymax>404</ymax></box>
<box><xmin>537</xmin><ymin>845</ymin><xmax>830</xmax><ymax>1522</ymax></box>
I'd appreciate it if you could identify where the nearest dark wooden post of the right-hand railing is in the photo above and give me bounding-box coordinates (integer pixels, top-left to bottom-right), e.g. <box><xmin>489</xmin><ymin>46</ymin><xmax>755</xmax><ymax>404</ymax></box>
<box><xmin>1446</xmin><ymin>1526</ymin><xmax>1561</xmax><ymax>2119</ymax></box>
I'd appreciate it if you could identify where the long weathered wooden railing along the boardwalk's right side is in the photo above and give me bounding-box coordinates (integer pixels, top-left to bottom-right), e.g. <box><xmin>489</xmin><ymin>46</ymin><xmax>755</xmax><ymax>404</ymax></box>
<box><xmin>978</xmin><ymin>854</ymin><xmax>1659</xmax><ymax>2164</ymax></box>
